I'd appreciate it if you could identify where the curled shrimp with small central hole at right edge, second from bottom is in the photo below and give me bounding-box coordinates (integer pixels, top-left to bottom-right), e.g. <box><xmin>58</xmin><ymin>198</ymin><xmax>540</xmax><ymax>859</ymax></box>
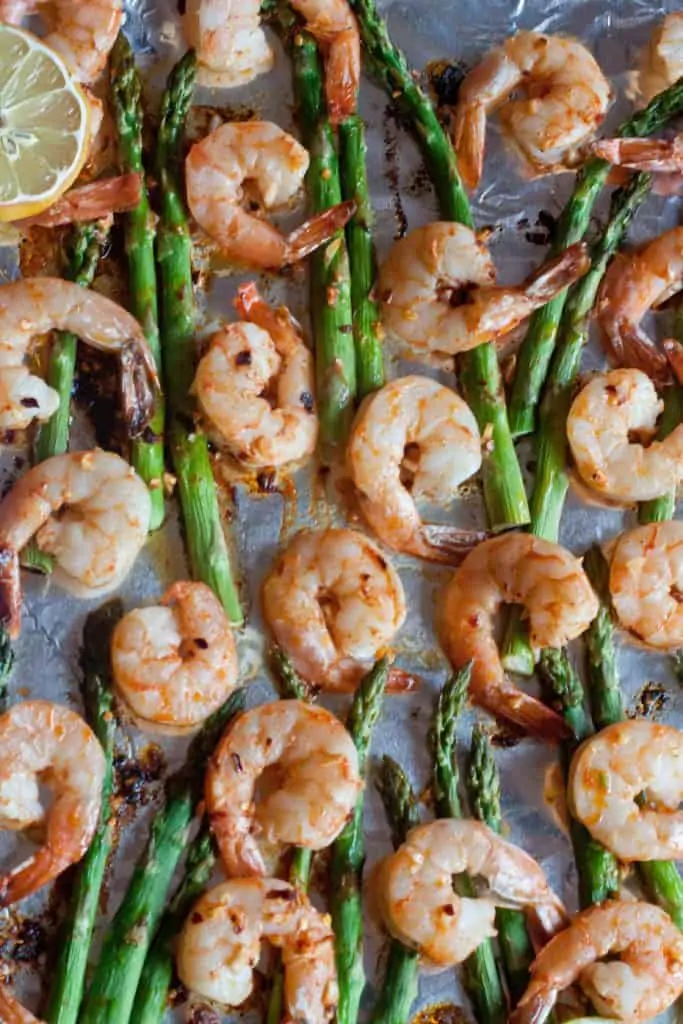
<box><xmin>567</xmin><ymin>721</ymin><xmax>683</xmax><ymax>861</ymax></box>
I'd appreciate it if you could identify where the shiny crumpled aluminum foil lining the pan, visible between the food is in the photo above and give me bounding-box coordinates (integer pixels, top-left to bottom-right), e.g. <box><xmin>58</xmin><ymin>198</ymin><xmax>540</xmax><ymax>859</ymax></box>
<box><xmin>0</xmin><ymin>0</ymin><xmax>683</xmax><ymax>1022</ymax></box>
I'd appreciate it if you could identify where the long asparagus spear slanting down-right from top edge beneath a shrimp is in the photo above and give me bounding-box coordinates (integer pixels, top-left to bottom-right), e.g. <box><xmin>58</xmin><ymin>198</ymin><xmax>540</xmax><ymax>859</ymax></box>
<box><xmin>351</xmin><ymin>0</ymin><xmax>529</xmax><ymax>528</ymax></box>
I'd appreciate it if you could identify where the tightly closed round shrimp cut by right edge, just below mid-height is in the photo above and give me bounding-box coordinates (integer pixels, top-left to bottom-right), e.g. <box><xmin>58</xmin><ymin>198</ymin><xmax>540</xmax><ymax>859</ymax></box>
<box><xmin>609</xmin><ymin>522</ymin><xmax>683</xmax><ymax>649</ymax></box>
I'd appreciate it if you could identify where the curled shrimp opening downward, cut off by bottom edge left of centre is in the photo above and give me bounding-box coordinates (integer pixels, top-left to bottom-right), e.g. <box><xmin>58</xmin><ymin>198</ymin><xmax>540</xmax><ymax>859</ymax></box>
<box><xmin>176</xmin><ymin>879</ymin><xmax>338</xmax><ymax>1024</ymax></box>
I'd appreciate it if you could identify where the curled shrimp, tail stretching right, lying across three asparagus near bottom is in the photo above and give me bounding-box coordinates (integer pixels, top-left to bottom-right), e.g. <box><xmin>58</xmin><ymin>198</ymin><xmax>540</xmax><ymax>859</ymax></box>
<box><xmin>378</xmin><ymin>818</ymin><xmax>564</xmax><ymax>968</ymax></box>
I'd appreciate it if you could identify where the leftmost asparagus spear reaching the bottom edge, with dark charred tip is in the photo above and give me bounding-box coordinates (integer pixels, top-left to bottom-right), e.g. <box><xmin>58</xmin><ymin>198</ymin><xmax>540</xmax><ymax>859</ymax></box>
<box><xmin>46</xmin><ymin>600</ymin><xmax>123</xmax><ymax>1024</ymax></box>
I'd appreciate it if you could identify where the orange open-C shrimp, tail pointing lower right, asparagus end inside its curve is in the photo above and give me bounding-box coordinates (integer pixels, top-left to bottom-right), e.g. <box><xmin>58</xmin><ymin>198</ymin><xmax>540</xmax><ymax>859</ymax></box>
<box><xmin>439</xmin><ymin>534</ymin><xmax>598</xmax><ymax>740</ymax></box>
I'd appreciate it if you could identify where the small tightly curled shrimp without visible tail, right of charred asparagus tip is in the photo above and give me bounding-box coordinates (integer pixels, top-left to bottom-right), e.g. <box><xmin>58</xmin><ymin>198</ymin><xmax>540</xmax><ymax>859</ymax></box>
<box><xmin>112</xmin><ymin>581</ymin><xmax>239</xmax><ymax>726</ymax></box>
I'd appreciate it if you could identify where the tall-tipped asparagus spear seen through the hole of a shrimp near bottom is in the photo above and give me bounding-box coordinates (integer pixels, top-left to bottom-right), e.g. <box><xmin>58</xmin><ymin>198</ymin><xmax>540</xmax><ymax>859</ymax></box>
<box><xmin>433</xmin><ymin>665</ymin><xmax>508</xmax><ymax>1024</ymax></box>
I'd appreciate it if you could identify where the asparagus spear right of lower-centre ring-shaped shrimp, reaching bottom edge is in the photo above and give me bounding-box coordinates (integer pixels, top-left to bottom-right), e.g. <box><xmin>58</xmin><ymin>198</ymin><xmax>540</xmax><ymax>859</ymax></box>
<box><xmin>331</xmin><ymin>657</ymin><xmax>389</xmax><ymax>1024</ymax></box>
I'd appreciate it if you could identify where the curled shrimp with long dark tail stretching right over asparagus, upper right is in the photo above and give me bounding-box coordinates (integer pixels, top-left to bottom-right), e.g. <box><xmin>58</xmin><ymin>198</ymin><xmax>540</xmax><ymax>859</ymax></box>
<box><xmin>379</xmin><ymin>221</ymin><xmax>589</xmax><ymax>361</ymax></box>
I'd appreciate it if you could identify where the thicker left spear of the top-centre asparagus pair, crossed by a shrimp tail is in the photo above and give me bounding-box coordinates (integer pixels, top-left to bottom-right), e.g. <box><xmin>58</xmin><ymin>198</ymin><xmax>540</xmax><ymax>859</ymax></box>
<box><xmin>288</xmin><ymin>25</ymin><xmax>356</xmax><ymax>445</ymax></box>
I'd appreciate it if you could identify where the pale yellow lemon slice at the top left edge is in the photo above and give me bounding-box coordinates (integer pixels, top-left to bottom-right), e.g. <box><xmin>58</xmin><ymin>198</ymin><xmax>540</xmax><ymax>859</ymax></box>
<box><xmin>0</xmin><ymin>24</ymin><xmax>90</xmax><ymax>221</ymax></box>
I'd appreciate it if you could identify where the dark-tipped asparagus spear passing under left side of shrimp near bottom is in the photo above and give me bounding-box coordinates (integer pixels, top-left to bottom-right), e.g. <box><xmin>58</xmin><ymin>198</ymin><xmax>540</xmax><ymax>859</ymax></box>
<box><xmin>371</xmin><ymin>756</ymin><xmax>420</xmax><ymax>1024</ymax></box>
